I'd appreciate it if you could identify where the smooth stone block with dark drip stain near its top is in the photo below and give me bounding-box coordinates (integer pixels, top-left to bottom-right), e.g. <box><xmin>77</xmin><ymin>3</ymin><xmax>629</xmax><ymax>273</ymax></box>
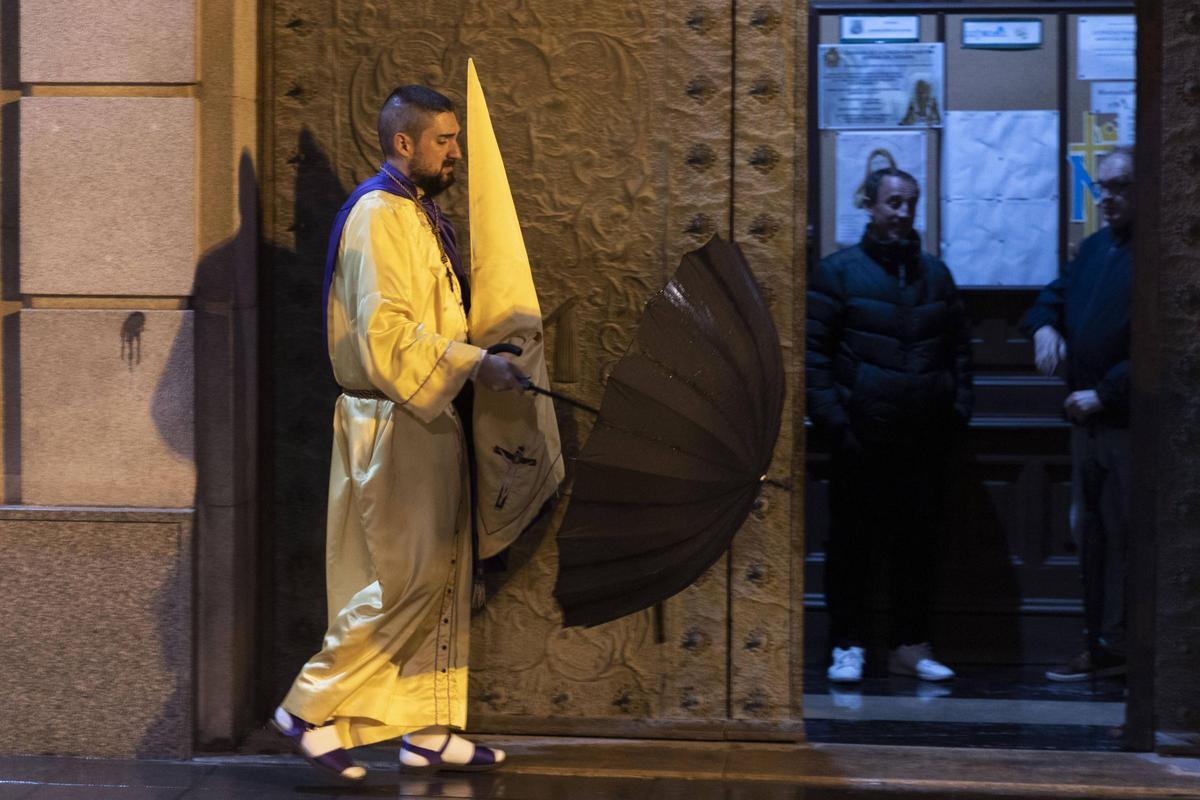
<box><xmin>20</xmin><ymin>308</ymin><xmax>196</xmax><ymax>507</ymax></box>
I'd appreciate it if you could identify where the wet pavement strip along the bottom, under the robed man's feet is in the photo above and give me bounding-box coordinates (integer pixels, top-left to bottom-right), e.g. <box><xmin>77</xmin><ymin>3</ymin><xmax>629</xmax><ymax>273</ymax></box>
<box><xmin>0</xmin><ymin>736</ymin><xmax>1200</xmax><ymax>800</ymax></box>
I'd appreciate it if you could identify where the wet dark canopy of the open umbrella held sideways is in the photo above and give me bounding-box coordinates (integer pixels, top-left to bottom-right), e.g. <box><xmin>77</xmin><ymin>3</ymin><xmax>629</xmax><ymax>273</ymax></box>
<box><xmin>554</xmin><ymin>236</ymin><xmax>784</xmax><ymax>626</ymax></box>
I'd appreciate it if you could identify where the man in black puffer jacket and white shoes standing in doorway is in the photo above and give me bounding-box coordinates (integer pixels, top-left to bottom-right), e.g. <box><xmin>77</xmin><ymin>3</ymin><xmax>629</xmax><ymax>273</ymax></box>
<box><xmin>806</xmin><ymin>168</ymin><xmax>973</xmax><ymax>682</ymax></box>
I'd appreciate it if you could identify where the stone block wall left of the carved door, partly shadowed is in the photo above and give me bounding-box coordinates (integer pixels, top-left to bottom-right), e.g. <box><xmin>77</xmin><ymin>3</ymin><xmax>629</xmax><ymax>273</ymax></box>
<box><xmin>0</xmin><ymin>0</ymin><xmax>258</xmax><ymax>756</ymax></box>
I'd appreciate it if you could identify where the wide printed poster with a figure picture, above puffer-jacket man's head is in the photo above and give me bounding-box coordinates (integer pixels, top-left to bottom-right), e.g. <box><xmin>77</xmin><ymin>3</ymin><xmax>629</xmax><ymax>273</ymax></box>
<box><xmin>818</xmin><ymin>43</ymin><xmax>944</xmax><ymax>128</ymax></box>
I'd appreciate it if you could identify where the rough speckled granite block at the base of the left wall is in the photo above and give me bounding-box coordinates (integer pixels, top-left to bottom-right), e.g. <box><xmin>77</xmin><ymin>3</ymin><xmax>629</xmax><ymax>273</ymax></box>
<box><xmin>0</xmin><ymin>510</ymin><xmax>192</xmax><ymax>758</ymax></box>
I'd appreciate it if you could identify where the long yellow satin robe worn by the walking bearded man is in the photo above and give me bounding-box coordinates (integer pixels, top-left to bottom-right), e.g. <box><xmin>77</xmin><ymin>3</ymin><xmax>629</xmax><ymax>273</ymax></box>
<box><xmin>283</xmin><ymin>192</ymin><xmax>481</xmax><ymax>747</ymax></box>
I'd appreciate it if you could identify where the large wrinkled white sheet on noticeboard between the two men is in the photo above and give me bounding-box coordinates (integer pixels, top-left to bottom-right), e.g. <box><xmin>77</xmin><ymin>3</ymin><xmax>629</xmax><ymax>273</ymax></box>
<box><xmin>941</xmin><ymin>112</ymin><xmax>1058</xmax><ymax>285</ymax></box>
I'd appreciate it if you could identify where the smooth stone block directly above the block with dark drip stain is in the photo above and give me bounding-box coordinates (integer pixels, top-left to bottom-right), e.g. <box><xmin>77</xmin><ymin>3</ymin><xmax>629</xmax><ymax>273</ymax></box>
<box><xmin>20</xmin><ymin>97</ymin><xmax>197</xmax><ymax>296</ymax></box>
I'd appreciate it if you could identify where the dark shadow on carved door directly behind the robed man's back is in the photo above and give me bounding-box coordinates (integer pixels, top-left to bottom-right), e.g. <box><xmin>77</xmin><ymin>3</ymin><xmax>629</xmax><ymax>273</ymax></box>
<box><xmin>258</xmin><ymin>128</ymin><xmax>349</xmax><ymax>712</ymax></box>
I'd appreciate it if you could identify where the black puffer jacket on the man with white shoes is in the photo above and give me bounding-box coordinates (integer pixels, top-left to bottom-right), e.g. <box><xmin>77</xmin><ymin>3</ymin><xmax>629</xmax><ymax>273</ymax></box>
<box><xmin>806</xmin><ymin>227</ymin><xmax>974</xmax><ymax>443</ymax></box>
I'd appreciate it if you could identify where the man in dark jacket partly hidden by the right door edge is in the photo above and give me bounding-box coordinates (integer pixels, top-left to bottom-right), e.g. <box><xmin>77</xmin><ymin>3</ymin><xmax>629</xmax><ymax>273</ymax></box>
<box><xmin>1021</xmin><ymin>149</ymin><xmax>1134</xmax><ymax>681</ymax></box>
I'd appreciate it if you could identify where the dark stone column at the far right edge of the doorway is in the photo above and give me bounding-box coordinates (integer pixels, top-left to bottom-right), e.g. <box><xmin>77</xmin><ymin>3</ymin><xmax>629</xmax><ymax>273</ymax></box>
<box><xmin>1128</xmin><ymin>0</ymin><xmax>1200</xmax><ymax>754</ymax></box>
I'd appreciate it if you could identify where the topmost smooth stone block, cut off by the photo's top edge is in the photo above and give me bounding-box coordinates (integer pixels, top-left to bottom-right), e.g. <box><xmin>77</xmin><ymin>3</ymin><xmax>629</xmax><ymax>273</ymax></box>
<box><xmin>19</xmin><ymin>0</ymin><xmax>196</xmax><ymax>83</ymax></box>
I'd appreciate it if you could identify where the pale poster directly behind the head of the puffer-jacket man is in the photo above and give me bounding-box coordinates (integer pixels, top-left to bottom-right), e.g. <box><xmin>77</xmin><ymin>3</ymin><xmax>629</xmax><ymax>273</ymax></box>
<box><xmin>835</xmin><ymin>131</ymin><xmax>928</xmax><ymax>247</ymax></box>
